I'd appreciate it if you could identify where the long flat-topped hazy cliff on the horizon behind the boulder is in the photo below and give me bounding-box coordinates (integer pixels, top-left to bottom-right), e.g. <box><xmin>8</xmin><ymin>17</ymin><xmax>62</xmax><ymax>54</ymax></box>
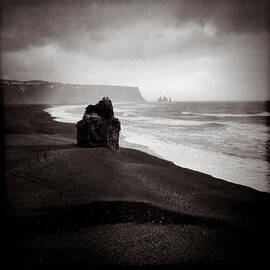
<box><xmin>0</xmin><ymin>80</ymin><xmax>144</xmax><ymax>104</ymax></box>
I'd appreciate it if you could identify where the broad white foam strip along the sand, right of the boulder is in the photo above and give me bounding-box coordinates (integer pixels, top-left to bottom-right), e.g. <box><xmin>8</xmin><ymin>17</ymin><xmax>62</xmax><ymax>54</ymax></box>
<box><xmin>123</xmin><ymin>129</ymin><xmax>269</xmax><ymax>191</ymax></box>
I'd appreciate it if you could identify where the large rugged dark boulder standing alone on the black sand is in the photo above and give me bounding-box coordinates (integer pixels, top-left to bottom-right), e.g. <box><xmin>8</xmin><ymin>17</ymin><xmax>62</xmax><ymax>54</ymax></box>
<box><xmin>76</xmin><ymin>97</ymin><xmax>121</xmax><ymax>150</ymax></box>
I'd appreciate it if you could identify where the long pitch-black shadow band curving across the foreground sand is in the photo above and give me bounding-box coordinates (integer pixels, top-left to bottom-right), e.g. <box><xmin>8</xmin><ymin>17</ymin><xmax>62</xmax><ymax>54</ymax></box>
<box><xmin>10</xmin><ymin>201</ymin><xmax>243</xmax><ymax>235</ymax></box>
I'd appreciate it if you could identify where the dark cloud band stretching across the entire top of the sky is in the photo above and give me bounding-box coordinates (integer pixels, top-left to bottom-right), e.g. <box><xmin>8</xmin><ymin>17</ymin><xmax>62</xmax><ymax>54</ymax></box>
<box><xmin>1</xmin><ymin>0</ymin><xmax>269</xmax><ymax>51</ymax></box>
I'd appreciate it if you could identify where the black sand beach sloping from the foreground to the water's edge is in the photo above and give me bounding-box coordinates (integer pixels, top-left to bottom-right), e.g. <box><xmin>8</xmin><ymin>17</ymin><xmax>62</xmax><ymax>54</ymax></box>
<box><xmin>3</xmin><ymin>105</ymin><xmax>270</xmax><ymax>268</ymax></box>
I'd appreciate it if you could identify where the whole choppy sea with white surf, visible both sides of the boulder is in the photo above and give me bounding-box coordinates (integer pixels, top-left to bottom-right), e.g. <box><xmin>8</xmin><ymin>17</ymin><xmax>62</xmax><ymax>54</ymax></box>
<box><xmin>46</xmin><ymin>102</ymin><xmax>270</xmax><ymax>192</ymax></box>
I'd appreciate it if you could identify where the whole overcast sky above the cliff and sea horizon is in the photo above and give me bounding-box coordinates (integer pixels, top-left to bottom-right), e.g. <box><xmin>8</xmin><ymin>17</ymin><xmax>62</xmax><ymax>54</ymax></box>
<box><xmin>0</xmin><ymin>0</ymin><xmax>269</xmax><ymax>100</ymax></box>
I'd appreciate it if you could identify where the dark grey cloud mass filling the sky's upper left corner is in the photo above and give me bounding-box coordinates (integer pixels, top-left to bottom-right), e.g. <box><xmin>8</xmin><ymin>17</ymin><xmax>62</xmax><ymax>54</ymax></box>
<box><xmin>1</xmin><ymin>1</ymin><xmax>103</xmax><ymax>51</ymax></box>
